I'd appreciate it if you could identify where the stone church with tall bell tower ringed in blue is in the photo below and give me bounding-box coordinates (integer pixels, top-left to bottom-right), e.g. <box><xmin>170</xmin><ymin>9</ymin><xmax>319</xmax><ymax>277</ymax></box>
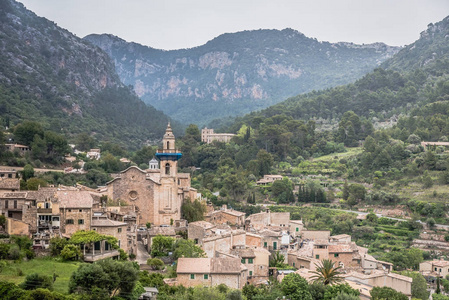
<box><xmin>107</xmin><ymin>123</ymin><xmax>197</xmax><ymax>225</ymax></box>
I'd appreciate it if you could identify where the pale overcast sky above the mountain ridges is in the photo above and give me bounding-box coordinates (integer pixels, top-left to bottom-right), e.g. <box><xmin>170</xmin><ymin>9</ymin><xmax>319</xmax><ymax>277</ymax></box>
<box><xmin>19</xmin><ymin>0</ymin><xmax>449</xmax><ymax>50</ymax></box>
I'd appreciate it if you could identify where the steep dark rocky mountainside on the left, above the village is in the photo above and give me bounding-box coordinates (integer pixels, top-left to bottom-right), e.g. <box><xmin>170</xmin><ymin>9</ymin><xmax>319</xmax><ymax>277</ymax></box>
<box><xmin>0</xmin><ymin>0</ymin><xmax>177</xmax><ymax>147</ymax></box>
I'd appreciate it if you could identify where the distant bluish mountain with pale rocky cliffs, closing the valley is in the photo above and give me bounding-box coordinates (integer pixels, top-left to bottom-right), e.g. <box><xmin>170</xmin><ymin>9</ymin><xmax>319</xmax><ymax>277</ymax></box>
<box><xmin>84</xmin><ymin>29</ymin><xmax>399</xmax><ymax>125</ymax></box>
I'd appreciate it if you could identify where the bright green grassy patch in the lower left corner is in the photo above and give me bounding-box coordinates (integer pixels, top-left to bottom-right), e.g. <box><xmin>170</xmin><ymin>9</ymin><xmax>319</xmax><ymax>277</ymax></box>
<box><xmin>0</xmin><ymin>258</ymin><xmax>81</xmax><ymax>294</ymax></box>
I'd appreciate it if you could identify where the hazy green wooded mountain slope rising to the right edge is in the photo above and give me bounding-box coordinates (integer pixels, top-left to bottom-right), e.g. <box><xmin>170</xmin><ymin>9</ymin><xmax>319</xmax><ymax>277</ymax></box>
<box><xmin>222</xmin><ymin>17</ymin><xmax>449</xmax><ymax>135</ymax></box>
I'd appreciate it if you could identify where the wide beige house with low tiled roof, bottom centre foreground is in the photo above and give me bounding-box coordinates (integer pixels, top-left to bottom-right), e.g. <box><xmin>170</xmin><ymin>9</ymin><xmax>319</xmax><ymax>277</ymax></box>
<box><xmin>176</xmin><ymin>257</ymin><xmax>248</xmax><ymax>289</ymax></box>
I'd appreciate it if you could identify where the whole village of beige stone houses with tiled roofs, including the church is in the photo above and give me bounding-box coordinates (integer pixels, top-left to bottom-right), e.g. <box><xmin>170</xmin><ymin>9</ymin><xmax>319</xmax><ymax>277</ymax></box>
<box><xmin>0</xmin><ymin>124</ymin><xmax>449</xmax><ymax>299</ymax></box>
